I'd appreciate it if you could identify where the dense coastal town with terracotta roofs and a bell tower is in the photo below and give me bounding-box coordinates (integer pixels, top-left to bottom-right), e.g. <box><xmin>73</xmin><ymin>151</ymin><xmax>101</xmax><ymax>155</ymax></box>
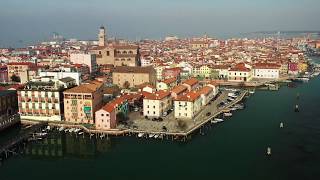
<box><xmin>0</xmin><ymin>26</ymin><xmax>320</xmax><ymax>145</ymax></box>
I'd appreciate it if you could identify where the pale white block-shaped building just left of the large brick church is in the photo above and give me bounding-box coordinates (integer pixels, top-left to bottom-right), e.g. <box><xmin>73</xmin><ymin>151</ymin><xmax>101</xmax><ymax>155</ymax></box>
<box><xmin>70</xmin><ymin>54</ymin><xmax>97</xmax><ymax>73</ymax></box>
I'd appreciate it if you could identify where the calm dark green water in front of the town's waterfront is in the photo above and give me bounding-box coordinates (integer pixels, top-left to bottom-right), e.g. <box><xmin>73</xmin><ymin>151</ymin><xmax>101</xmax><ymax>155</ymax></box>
<box><xmin>0</xmin><ymin>58</ymin><xmax>320</xmax><ymax>180</ymax></box>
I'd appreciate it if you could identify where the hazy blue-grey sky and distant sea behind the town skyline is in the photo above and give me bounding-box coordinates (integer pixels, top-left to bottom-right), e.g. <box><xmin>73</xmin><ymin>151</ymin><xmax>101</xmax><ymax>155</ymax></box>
<box><xmin>0</xmin><ymin>0</ymin><xmax>320</xmax><ymax>47</ymax></box>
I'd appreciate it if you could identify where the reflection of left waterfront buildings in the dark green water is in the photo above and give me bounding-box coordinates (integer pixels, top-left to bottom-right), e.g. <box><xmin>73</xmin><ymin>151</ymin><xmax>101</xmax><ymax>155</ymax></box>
<box><xmin>25</xmin><ymin>132</ymin><xmax>112</xmax><ymax>159</ymax></box>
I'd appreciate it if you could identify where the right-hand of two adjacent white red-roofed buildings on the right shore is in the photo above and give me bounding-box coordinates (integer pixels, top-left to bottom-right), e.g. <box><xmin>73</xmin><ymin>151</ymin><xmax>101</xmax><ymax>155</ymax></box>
<box><xmin>253</xmin><ymin>63</ymin><xmax>281</xmax><ymax>79</ymax></box>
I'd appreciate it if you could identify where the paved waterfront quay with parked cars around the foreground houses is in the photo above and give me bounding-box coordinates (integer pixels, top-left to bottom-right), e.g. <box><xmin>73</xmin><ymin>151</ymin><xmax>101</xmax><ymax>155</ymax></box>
<box><xmin>22</xmin><ymin>90</ymin><xmax>248</xmax><ymax>139</ymax></box>
